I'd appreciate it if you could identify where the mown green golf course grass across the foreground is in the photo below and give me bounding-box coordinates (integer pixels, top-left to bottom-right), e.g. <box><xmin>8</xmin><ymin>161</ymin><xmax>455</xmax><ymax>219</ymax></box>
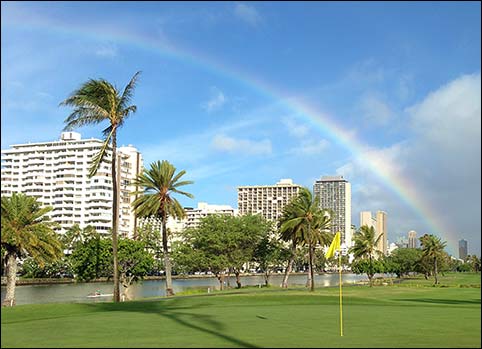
<box><xmin>1</xmin><ymin>274</ymin><xmax>481</xmax><ymax>348</ymax></box>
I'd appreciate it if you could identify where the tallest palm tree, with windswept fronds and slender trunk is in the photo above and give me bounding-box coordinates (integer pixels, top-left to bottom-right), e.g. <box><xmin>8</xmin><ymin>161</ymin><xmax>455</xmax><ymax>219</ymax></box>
<box><xmin>60</xmin><ymin>72</ymin><xmax>140</xmax><ymax>302</ymax></box>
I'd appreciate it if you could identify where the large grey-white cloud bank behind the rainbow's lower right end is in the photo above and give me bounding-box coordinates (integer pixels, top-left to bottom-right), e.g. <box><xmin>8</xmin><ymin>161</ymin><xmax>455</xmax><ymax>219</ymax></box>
<box><xmin>337</xmin><ymin>74</ymin><xmax>481</xmax><ymax>253</ymax></box>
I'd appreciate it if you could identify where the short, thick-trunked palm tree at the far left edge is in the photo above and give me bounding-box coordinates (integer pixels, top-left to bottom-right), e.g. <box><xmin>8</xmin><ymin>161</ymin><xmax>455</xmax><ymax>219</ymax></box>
<box><xmin>1</xmin><ymin>192</ymin><xmax>62</xmax><ymax>306</ymax></box>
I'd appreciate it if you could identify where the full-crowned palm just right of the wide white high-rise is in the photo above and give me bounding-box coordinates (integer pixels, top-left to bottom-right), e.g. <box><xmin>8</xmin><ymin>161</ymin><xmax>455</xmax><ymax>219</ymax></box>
<box><xmin>132</xmin><ymin>160</ymin><xmax>194</xmax><ymax>296</ymax></box>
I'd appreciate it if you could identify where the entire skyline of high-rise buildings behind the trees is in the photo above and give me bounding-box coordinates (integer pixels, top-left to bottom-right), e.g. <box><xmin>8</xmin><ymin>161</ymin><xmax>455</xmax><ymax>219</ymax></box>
<box><xmin>1</xmin><ymin>132</ymin><xmax>474</xmax><ymax>257</ymax></box>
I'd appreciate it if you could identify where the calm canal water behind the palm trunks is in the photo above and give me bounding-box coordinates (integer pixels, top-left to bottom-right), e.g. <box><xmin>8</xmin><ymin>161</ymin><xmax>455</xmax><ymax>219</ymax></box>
<box><xmin>1</xmin><ymin>273</ymin><xmax>366</xmax><ymax>305</ymax></box>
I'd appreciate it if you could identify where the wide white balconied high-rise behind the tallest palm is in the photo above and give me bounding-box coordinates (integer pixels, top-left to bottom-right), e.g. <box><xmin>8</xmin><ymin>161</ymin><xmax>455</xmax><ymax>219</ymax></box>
<box><xmin>1</xmin><ymin>132</ymin><xmax>143</xmax><ymax>236</ymax></box>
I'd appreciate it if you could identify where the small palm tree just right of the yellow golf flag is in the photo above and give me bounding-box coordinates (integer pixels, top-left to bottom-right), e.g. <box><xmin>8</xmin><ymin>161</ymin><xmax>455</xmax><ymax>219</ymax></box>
<box><xmin>350</xmin><ymin>225</ymin><xmax>383</xmax><ymax>286</ymax></box>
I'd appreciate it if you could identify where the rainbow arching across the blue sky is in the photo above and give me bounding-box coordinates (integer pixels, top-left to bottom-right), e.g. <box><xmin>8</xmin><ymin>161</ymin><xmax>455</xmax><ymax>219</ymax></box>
<box><xmin>2</xmin><ymin>13</ymin><xmax>458</xmax><ymax>252</ymax></box>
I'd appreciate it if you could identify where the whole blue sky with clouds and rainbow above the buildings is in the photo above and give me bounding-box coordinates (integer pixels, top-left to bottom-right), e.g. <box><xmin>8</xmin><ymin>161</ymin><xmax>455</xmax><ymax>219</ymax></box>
<box><xmin>1</xmin><ymin>1</ymin><xmax>481</xmax><ymax>255</ymax></box>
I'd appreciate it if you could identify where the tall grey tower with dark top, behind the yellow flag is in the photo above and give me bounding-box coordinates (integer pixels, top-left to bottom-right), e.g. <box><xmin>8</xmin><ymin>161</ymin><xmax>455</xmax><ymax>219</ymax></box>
<box><xmin>313</xmin><ymin>176</ymin><xmax>352</xmax><ymax>247</ymax></box>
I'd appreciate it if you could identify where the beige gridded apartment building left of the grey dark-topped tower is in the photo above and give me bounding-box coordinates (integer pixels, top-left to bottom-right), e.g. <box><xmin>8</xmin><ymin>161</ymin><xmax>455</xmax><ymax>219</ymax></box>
<box><xmin>238</xmin><ymin>178</ymin><xmax>301</xmax><ymax>221</ymax></box>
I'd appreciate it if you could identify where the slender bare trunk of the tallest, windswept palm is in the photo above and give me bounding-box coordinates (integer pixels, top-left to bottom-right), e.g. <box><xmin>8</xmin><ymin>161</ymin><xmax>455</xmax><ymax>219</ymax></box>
<box><xmin>112</xmin><ymin>130</ymin><xmax>120</xmax><ymax>302</ymax></box>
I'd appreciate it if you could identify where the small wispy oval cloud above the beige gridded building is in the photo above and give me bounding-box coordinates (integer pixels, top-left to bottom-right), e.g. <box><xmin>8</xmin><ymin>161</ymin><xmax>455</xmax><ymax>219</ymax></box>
<box><xmin>212</xmin><ymin>135</ymin><xmax>272</xmax><ymax>155</ymax></box>
